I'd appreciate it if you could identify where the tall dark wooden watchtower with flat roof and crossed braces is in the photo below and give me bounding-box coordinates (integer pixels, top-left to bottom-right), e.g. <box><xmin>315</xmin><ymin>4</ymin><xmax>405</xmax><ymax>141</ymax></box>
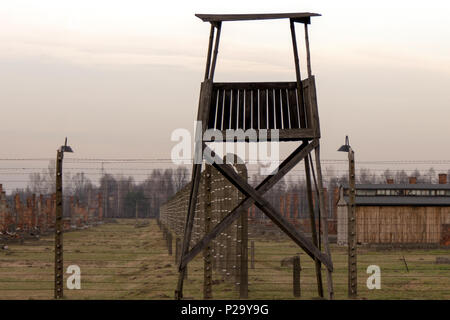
<box><xmin>175</xmin><ymin>12</ymin><xmax>334</xmax><ymax>299</ymax></box>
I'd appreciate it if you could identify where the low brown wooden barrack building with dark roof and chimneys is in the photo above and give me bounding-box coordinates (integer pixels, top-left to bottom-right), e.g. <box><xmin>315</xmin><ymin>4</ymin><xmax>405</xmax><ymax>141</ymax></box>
<box><xmin>337</xmin><ymin>174</ymin><xmax>450</xmax><ymax>246</ymax></box>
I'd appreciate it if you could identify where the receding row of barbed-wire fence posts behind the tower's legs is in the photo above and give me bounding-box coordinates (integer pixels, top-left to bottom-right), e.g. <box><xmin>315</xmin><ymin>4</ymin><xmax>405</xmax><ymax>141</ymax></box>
<box><xmin>160</xmin><ymin>164</ymin><xmax>248</xmax><ymax>299</ymax></box>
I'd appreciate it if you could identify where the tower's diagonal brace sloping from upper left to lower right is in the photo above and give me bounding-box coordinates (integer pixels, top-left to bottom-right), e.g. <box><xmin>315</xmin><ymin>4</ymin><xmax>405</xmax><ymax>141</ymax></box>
<box><xmin>206</xmin><ymin>153</ymin><xmax>333</xmax><ymax>271</ymax></box>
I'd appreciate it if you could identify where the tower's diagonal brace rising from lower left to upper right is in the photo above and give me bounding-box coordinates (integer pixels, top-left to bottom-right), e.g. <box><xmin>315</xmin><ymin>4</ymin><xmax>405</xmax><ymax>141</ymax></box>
<box><xmin>181</xmin><ymin>140</ymin><xmax>317</xmax><ymax>265</ymax></box>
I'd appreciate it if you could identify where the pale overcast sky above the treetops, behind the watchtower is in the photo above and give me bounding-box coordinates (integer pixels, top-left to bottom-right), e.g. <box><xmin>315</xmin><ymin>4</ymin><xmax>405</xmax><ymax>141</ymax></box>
<box><xmin>0</xmin><ymin>0</ymin><xmax>450</xmax><ymax>160</ymax></box>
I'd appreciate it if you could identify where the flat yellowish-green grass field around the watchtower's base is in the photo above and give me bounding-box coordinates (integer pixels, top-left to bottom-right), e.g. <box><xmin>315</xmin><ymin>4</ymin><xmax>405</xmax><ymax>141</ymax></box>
<box><xmin>0</xmin><ymin>220</ymin><xmax>450</xmax><ymax>299</ymax></box>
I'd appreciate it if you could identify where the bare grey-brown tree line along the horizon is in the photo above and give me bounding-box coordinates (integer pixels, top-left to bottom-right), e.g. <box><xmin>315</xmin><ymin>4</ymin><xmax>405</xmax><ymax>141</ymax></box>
<box><xmin>10</xmin><ymin>161</ymin><xmax>450</xmax><ymax>218</ymax></box>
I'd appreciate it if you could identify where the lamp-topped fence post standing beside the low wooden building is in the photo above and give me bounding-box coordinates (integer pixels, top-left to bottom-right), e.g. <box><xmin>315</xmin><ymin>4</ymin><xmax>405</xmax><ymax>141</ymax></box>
<box><xmin>338</xmin><ymin>136</ymin><xmax>358</xmax><ymax>298</ymax></box>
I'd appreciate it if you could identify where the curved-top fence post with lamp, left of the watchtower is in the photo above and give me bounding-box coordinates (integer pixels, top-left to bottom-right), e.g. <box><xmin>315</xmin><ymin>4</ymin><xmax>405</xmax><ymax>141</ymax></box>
<box><xmin>55</xmin><ymin>138</ymin><xmax>73</xmax><ymax>299</ymax></box>
